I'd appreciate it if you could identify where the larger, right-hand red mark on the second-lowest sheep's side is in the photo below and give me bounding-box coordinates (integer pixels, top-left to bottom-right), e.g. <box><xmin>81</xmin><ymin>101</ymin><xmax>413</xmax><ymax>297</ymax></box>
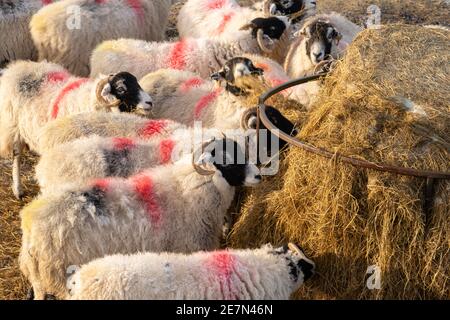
<box><xmin>131</xmin><ymin>174</ymin><xmax>161</xmax><ymax>225</ymax></box>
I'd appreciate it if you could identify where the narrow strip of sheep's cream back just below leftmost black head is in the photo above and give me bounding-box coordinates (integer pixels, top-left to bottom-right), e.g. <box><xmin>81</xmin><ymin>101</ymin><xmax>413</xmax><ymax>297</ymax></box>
<box><xmin>38</xmin><ymin>112</ymin><xmax>184</xmax><ymax>155</ymax></box>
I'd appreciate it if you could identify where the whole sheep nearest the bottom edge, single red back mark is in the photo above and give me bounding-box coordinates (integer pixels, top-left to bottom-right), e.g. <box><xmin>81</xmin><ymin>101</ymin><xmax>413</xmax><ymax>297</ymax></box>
<box><xmin>67</xmin><ymin>243</ymin><xmax>315</xmax><ymax>300</ymax></box>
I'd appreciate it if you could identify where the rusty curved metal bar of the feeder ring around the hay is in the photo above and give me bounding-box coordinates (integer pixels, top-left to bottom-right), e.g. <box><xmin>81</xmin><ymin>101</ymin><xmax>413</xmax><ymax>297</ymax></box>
<box><xmin>257</xmin><ymin>72</ymin><xmax>450</xmax><ymax>179</ymax></box>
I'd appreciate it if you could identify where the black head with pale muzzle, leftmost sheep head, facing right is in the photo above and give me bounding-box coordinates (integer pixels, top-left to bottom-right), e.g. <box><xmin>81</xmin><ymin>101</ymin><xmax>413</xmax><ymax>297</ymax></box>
<box><xmin>102</xmin><ymin>72</ymin><xmax>153</xmax><ymax>114</ymax></box>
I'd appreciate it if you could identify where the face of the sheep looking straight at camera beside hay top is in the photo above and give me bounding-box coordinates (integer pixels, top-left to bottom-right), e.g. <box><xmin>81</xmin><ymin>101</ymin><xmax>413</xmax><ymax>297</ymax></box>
<box><xmin>300</xmin><ymin>21</ymin><xmax>342</xmax><ymax>65</ymax></box>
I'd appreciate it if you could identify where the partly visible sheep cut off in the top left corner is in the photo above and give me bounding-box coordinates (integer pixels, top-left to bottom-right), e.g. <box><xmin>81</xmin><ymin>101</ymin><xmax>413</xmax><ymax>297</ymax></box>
<box><xmin>0</xmin><ymin>0</ymin><xmax>57</xmax><ymax>68</ymax></box>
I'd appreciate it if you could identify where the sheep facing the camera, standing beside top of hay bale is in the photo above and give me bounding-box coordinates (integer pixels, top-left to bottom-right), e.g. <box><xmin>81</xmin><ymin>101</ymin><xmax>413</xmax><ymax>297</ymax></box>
<box><xmin>284</xmin><ymin>12</ymin><xmax>362</xmax><ymax>78</ymax></box>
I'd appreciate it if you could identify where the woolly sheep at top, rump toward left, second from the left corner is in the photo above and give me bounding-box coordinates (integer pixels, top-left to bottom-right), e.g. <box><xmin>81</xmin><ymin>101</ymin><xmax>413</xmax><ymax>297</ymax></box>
<box><xmin>30</xmin><ymin>0</ymin><xmax>178</xmax><ymax>76</ymax></box>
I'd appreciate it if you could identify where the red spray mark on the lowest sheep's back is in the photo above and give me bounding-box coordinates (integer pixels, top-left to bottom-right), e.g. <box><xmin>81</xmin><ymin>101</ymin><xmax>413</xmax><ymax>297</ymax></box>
<box><xmin>206</xmin><ymin>250</ymin><xmax>238</xmax><ymax>300</ymax></box>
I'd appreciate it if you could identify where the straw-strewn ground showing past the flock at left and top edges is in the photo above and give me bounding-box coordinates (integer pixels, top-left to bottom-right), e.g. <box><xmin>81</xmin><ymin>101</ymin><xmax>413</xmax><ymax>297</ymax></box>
<box><xmin>0</xmin><ymin>0</ymin><xmax>450</xmax><ymax>299</ymax></box>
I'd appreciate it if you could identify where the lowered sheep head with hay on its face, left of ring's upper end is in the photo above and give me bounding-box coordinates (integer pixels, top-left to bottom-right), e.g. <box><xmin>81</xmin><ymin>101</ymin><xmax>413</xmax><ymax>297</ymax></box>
<box><xmin>211</xmin><ymin>57</ymin><xmax>264</xmax><ymax>84</ymax></box>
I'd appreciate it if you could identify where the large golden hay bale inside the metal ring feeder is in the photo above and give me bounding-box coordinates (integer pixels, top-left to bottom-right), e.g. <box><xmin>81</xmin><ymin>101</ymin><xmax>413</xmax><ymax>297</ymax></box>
<box><xmin>230</xmin><ymin>25</ymin><xmax>450</xmax><ymax>299</ymax></box>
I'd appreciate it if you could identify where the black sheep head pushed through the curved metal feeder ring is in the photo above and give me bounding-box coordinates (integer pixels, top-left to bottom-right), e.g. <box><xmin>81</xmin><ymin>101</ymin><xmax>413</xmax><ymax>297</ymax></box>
<box><xmin>243</xmin><ymin>106</ymin><xmax>298</xmax><ymax>158</ymax></box>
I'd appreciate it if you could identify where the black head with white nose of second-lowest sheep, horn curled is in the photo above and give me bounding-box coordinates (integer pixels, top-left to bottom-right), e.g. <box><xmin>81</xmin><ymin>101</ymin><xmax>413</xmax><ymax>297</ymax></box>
<box><xmin>196</xmin><ymin>139</ymin><xmax>262</xmax><ymax>187</ymax></box>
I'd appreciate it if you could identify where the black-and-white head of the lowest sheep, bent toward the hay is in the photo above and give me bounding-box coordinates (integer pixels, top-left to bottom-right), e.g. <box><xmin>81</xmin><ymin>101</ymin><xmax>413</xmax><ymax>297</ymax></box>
<box><xmin>272</xmin><ymin>243</ymin><xmax>316</xmax><ymax>288</ymax></box>
